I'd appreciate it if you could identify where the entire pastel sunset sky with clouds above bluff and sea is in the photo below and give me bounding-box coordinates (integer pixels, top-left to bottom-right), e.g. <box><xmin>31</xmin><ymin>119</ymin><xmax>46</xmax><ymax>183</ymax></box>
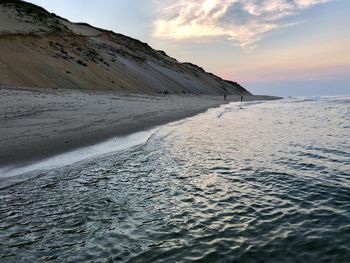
<box><xmin>29</xmin><ymin>0</ymin><xmax>350</xmax><ymax>96</ymax></box>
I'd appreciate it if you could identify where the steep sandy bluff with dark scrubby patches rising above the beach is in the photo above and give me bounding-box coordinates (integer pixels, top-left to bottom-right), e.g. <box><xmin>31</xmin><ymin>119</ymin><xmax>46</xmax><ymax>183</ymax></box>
<box><xmin>0</xmin><ymin>0</ymin><xmax>250</xmax><ymax>95</ymax></box>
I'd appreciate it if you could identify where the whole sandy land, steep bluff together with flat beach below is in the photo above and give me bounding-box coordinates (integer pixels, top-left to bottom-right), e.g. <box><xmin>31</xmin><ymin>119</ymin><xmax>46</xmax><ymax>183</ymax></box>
<box><xmin>0</xmin><ymin>1</ymin><xmax>257</xmax><ymax>169</ymax></box>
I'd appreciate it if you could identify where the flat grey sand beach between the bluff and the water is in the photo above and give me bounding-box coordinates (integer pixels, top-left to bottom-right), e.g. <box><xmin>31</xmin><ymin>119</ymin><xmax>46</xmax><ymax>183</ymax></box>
<box><xmin>0</xmin><ymin>87</ymin><xmax>279</xmax><ymax>167</ymax></box>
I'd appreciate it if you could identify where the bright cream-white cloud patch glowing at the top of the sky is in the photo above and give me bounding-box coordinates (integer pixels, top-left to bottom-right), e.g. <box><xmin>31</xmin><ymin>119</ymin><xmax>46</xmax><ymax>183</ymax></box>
<box><xmin>154</xmin><ymin>0</ymin><xmax>332</xmax><ymax>47</ymax></box>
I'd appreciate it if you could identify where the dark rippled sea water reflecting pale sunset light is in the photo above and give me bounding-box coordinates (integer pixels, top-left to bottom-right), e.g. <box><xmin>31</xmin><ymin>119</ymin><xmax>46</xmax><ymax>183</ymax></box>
<box><xmin>0</xmin><ymin>97</ymin><xmax>350</xmax><ymax>262</ymax></box>
